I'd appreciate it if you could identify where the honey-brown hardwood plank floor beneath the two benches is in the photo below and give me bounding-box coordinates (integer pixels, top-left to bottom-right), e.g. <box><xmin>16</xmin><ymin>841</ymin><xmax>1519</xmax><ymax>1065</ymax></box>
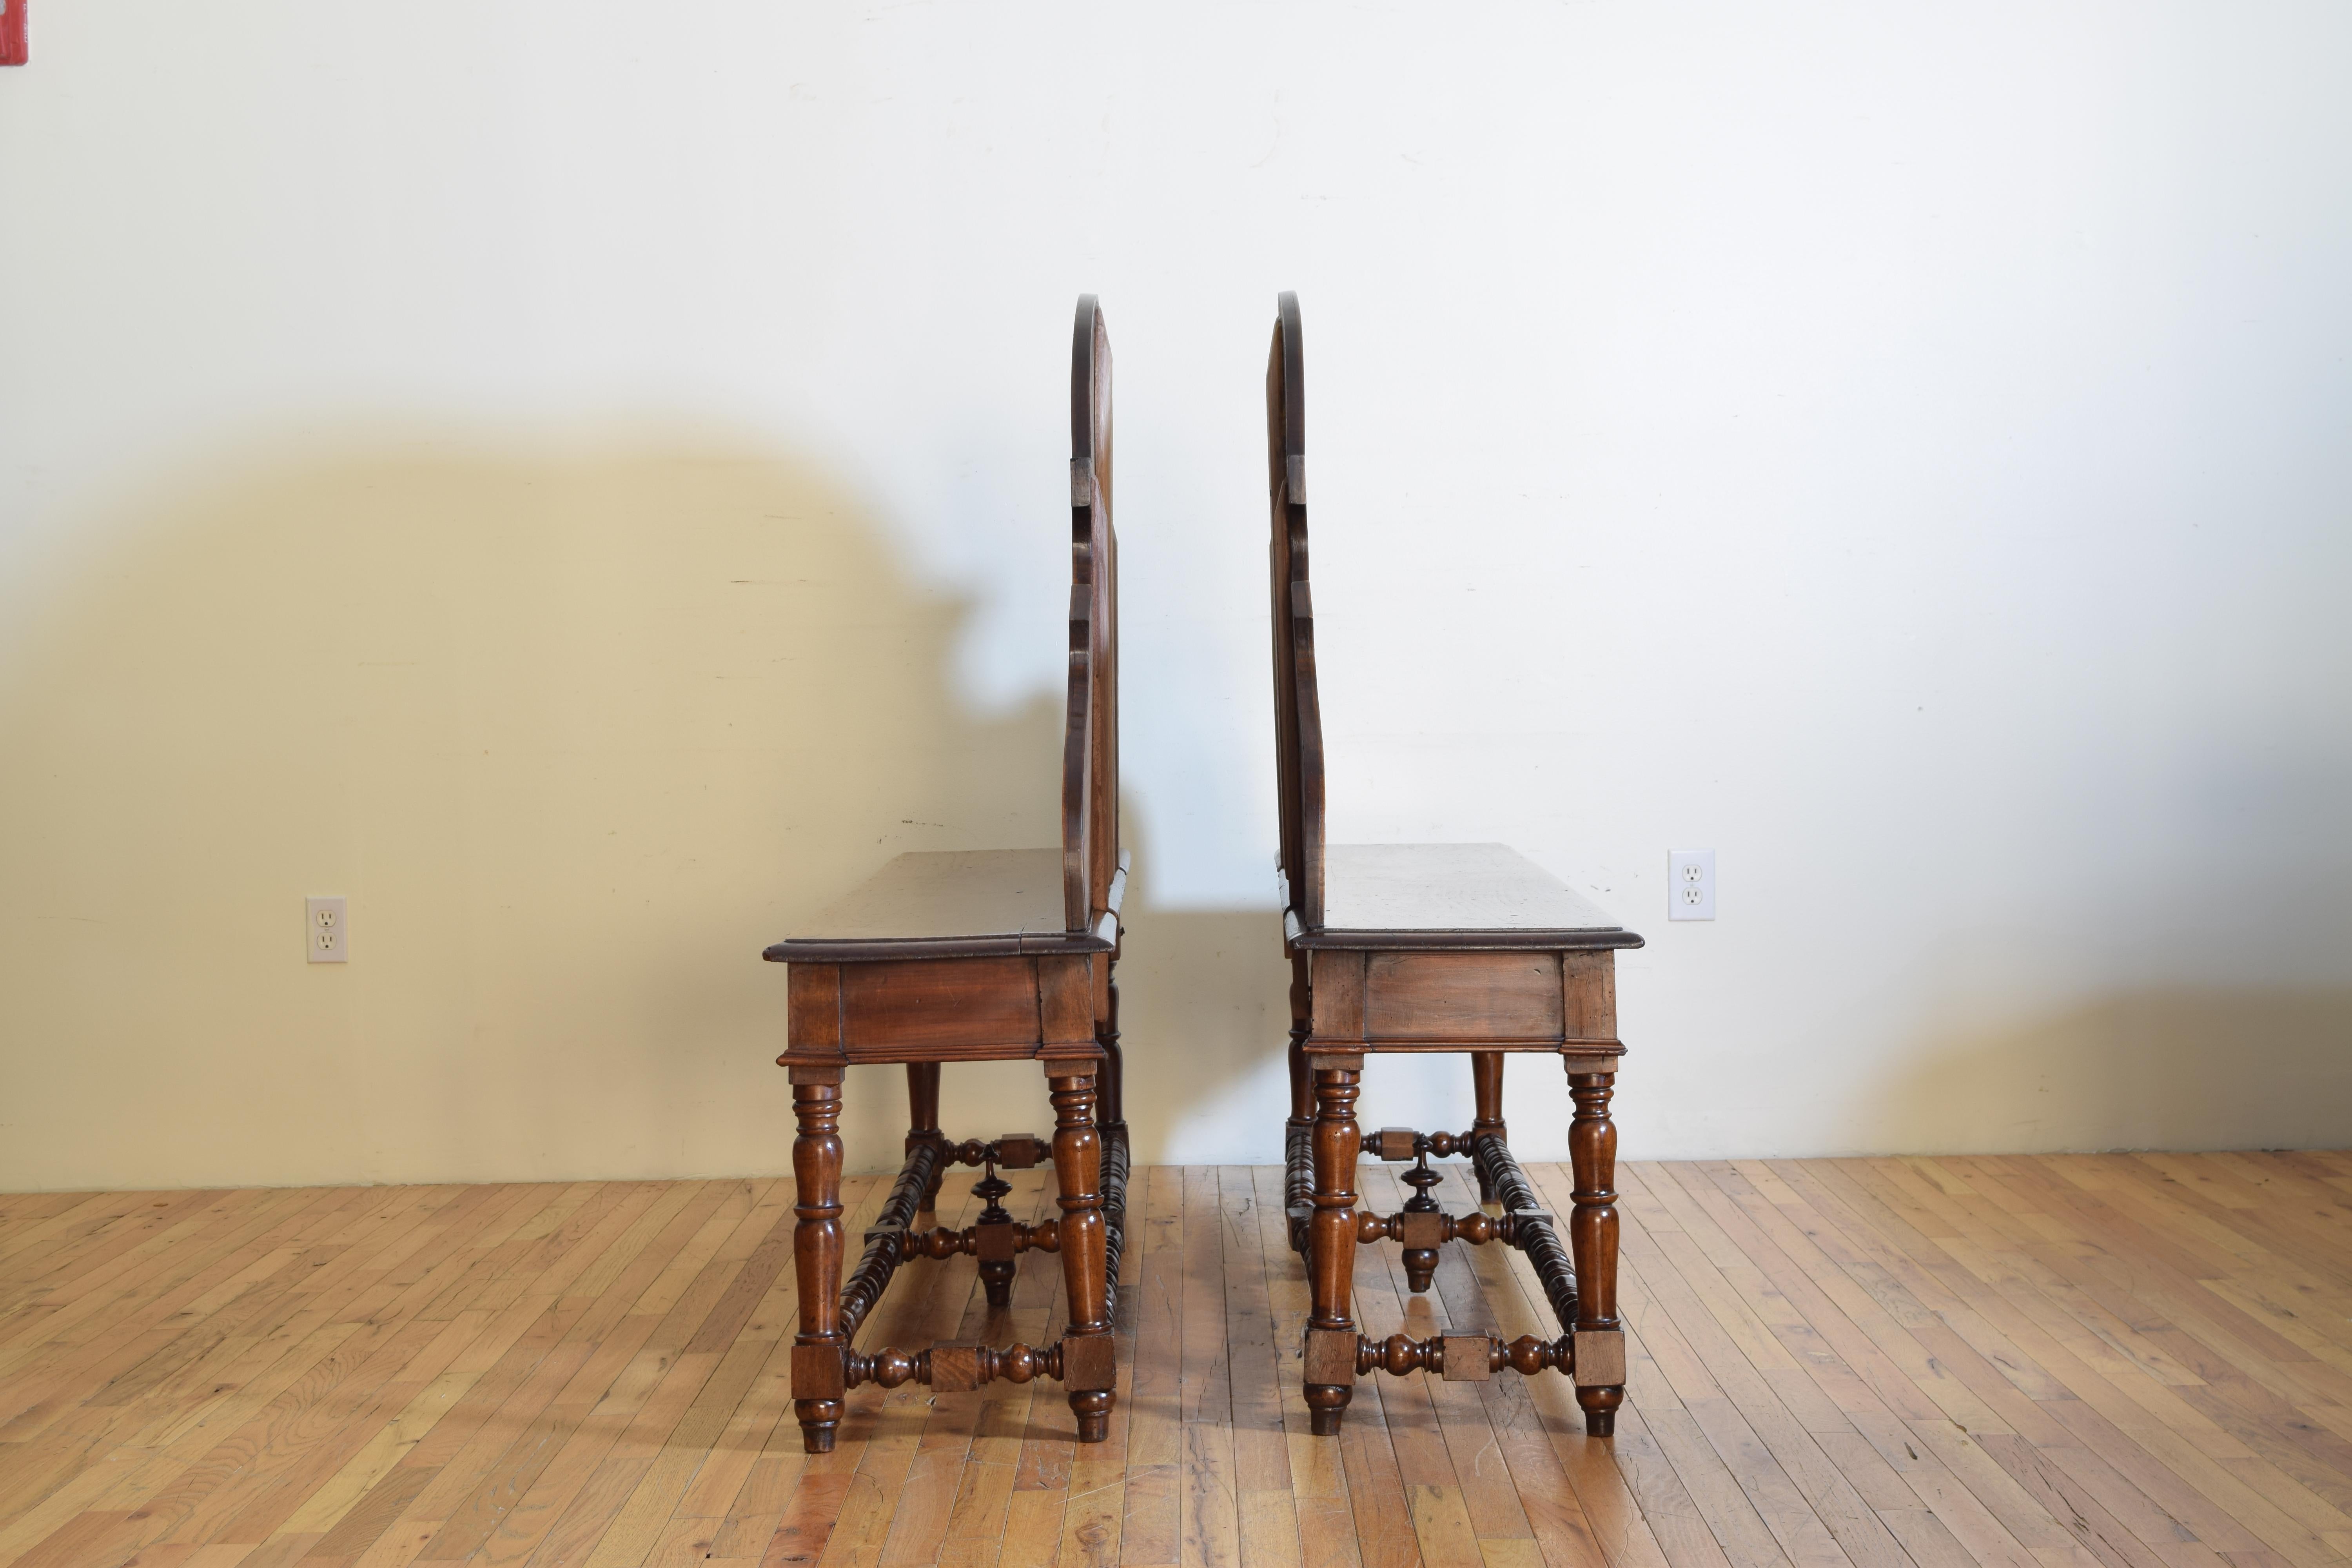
<box><xmin>0</xmin><ymin>1154</ymin><xmax>2352</xmax><ymax>1568</ymax></box>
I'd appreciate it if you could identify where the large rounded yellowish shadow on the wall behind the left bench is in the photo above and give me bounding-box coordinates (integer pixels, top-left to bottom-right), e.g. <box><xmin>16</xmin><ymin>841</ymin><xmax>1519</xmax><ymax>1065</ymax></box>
<box><xmin>0</xmin><ymin>439</ymin><xmax>1282</xmax><ymax>1189</ymax></box>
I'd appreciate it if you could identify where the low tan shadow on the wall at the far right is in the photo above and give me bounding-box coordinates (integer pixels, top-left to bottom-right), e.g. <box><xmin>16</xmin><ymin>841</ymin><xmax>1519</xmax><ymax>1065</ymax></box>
<box><xmin>1860</xmin><ymin>987</ymin><xmax>2352</xmax><ymax>1154</ymax></box>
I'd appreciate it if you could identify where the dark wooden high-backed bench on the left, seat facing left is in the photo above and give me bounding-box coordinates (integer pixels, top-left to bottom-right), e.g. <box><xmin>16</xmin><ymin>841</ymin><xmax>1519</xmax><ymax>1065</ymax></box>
<box><xmin>762</xmin><ymin>294</ymin><xmax>1127</xmax><ymax>1453</ymax></box>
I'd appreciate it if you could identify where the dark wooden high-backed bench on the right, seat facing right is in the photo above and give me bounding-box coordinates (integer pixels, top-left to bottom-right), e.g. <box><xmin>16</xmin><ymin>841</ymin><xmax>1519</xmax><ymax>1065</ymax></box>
<box><xmin>1265</xmin><ymin>294</ymin><xmax>1642</xmax><ymax>1436</ymax></box>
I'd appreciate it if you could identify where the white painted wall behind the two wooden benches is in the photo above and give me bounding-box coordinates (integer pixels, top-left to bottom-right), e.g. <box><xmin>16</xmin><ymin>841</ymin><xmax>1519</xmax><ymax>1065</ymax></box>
<box><xmin>0</xmin><ymin>0</ymin><xmax>2352</xmax><ymax>1187</ymax></box>
